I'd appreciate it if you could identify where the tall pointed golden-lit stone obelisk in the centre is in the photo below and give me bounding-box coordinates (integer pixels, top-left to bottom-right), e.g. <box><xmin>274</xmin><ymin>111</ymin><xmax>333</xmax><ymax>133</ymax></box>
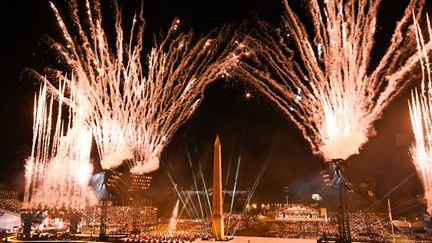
<box><xmin>212</xmin><ymin>135</ymin><xmax>225</xmax><ymax>240</ymax></box>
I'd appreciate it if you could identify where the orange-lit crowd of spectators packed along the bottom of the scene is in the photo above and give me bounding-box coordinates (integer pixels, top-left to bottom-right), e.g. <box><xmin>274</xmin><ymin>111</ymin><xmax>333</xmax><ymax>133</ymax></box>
<box><xmin>5</xmin><ymin>197</ymin><xmax>432</xmax><ymax>242</ymax></box>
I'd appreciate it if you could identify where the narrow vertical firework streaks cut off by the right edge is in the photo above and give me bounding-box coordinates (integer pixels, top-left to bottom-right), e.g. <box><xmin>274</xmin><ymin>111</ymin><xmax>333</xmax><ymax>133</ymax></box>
<box><xmin>408</xmin><ymin>14</ymin><xmax>432</xmax><ymax>214</ymax></box>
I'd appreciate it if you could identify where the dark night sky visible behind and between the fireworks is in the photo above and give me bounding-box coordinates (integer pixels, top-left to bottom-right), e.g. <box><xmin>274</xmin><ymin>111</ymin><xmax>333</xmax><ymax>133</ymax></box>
<box><xmin>0</xmin><ymin>0</ymin><xmax>421</xmax><ymax>216</ymax></box>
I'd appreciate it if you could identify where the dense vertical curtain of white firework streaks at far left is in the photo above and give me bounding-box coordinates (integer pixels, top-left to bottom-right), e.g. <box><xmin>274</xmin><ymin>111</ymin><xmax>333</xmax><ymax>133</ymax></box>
<box><xmin>24</xmin><ymin>79</ymin><xmax>96</xmax><ymax>209</ymax></box>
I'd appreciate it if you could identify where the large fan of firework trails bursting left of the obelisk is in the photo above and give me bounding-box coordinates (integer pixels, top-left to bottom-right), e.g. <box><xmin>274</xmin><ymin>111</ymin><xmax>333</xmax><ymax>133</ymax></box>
<box><xmin>29</xmin><ymin>0</ymin><xmax>238</xmax><ymax>174</ymax></box>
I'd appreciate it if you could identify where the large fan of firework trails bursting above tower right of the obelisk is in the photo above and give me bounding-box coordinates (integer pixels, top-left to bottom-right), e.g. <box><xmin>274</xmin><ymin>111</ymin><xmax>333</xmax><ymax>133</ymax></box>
<box><xmin>238</xmin><ymin>0</ymin><xmax>423</xmax><ymax>161</ymax></box>
